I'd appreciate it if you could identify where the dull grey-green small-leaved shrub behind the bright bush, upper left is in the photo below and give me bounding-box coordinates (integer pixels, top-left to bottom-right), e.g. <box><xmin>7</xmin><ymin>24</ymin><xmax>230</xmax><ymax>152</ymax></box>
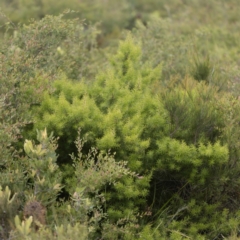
<box><xmin>0</xmin><ymin>12</ymin><xmax>104</xmax><ymax>156</ymax></box>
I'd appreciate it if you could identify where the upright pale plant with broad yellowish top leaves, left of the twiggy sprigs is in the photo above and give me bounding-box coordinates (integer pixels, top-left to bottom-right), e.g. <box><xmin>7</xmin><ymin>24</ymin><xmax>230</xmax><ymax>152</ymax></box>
<box><xmin>24</xmin><ymin>129</ymin><xmax>61</xmax><ymax>206</ymax></box>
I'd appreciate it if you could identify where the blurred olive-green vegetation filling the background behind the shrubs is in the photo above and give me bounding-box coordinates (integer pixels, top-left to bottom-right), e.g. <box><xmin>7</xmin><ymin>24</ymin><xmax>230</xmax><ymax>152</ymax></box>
<box><xmin>0</xmin><ymin>0</ymin><xmax>240</xmax><ymax>91</ymax></box>
